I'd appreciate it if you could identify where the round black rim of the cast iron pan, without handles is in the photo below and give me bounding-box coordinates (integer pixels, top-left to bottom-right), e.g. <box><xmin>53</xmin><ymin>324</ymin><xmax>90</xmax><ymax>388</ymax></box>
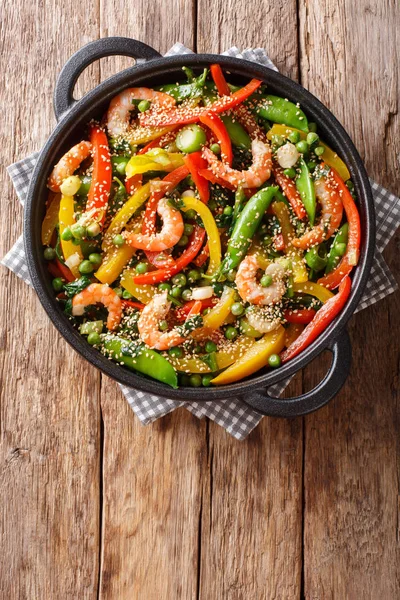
<box><xmin>24</xmin><ymin>54</ymin><xmax>375</xmax><ymax>402</ymax></box>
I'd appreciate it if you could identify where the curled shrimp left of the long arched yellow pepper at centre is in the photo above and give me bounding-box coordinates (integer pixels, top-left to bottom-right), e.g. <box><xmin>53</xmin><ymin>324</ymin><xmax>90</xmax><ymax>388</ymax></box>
<box><xmin>123</xmin><ymin>198</ymin><xmax>184</xmax><ymax>252</ymax></box>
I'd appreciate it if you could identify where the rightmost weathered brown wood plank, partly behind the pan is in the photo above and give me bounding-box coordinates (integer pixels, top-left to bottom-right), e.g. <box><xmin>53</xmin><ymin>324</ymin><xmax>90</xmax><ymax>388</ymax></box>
<box><xmin>300</xmin><ymin>1</ymin><xmax>400</xmax><ymax>600</ymax></box>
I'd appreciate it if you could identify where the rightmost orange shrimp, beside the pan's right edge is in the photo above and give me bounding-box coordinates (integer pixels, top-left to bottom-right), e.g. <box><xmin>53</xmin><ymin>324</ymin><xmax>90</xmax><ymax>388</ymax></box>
<box><xmin>292</xmin><ymin>177</ymin><xmax>343</xmax><ymax>250</ymax></box>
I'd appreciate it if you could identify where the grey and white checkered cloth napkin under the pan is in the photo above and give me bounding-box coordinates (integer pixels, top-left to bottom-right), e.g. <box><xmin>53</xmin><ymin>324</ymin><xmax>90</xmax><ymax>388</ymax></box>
<box><xmin>2</xmin><ymin>43</ymin><xmax>400</xmax><ymax>440</ymax></box>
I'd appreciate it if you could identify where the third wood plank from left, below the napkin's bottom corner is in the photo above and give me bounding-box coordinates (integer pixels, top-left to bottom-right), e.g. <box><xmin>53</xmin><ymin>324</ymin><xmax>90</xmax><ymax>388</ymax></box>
<box><xmin>197</xmin><ymin>0</ymin><xmax>302</xmax><ymax>600</ymax></box>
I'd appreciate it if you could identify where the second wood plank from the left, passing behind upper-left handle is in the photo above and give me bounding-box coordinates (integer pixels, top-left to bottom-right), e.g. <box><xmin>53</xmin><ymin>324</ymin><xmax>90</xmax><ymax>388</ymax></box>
<box><xmin>100</xmin><ymin>5</ymin><xmax>207</xmax><ymax>600</ymax></box>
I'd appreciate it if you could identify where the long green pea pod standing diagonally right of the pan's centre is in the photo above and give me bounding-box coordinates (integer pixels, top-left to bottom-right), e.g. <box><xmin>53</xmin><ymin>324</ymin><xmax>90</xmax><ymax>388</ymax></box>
<box><xmin>220</xmin><ymin>186</ymin><xmax>278</xmax><ymax>273</ymax></box>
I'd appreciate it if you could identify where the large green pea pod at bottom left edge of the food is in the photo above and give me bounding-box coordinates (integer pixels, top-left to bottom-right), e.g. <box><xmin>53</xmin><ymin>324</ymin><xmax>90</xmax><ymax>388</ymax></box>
<box><xmin>103</xmin><ymin>336</ymin><xmax>178</xmax><ymax>389</ymax></box>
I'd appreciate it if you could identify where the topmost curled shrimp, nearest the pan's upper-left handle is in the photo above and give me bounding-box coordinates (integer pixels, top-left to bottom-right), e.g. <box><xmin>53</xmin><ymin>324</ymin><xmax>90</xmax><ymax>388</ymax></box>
<box><xmin>107</xmin><ymin>88</ymin><xmax>175</xmax><ymax>137</ymax></box>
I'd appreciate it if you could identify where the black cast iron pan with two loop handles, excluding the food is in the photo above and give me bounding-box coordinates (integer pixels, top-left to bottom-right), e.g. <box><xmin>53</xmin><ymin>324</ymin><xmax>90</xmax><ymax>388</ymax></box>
<box><xmin>24</xmin><ymin>37</ymin><xmax>375</xmax><ymax>417</ymax></box>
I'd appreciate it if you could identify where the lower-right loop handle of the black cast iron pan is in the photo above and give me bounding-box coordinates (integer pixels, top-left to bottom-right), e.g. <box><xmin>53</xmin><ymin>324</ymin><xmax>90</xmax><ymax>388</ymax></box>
<box><xmin>241</xmin><ymin>330</ymin><xmax>351</xmax><ymax>418</ymax></box>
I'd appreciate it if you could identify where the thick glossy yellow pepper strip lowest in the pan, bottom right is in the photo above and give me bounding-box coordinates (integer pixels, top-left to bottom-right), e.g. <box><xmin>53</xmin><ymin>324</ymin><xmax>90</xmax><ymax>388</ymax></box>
<box><xmin>211</xmin><ymin>325</ymin><xmax>285</xmax><ymax>385</ymax></box>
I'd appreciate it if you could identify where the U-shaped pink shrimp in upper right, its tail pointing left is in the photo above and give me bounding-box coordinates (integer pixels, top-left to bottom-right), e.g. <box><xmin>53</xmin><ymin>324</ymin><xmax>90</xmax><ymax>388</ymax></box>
<box><xmin>203</xmin><ymin>140</ymin><xmax>272</xmax><ymax>188</ymax></box>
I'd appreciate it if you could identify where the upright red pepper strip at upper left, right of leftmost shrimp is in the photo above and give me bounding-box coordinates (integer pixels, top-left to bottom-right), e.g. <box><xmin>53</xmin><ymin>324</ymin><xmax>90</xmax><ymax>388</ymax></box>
<box><xmin>86</xmin><ymin>125</ymin><xmax>112</xmax><ymax>224</ymax></box>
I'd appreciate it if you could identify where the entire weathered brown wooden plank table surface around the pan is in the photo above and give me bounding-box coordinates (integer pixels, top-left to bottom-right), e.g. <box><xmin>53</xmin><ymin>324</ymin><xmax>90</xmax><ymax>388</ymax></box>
<box><xmin>0</xmin><ymin>0</ymin><xmax>400</xmax><ymax>600</ymax></box>
